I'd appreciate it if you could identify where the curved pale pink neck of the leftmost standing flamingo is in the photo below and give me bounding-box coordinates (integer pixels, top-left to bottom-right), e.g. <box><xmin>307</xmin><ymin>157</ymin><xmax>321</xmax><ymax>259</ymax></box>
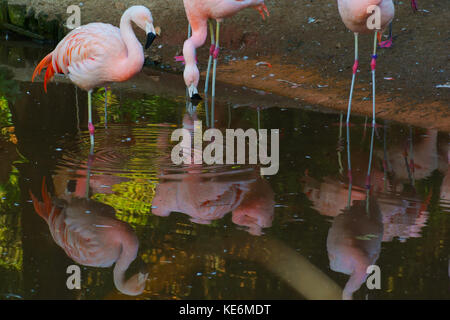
<box><xmin>117</xmin><ymin>12</ymin><xmax>144</xmax><ymax>81</ymax></box>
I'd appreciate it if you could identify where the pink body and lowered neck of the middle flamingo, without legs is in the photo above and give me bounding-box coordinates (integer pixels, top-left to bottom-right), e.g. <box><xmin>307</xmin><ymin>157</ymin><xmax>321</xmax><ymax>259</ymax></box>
<box><xmin>183</xmin><ymin>0</ymin><xmax>268</xmax><ymax>94</ymax></box>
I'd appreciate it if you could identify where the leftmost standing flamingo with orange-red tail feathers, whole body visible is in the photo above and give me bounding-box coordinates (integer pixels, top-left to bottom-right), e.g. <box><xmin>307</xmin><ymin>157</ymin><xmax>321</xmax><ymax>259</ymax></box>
<box><xmin>32</xmin><ymin>6</ymin><xmax>156</xmax><ymax>145</ymax></box>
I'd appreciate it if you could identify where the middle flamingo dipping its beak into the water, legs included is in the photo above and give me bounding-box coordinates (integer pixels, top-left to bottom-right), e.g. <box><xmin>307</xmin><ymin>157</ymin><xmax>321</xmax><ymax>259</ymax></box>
<box><xmin>183</xmin><ymin>0</ymin><xmax>269</xmax><ymax>100</ymax></box>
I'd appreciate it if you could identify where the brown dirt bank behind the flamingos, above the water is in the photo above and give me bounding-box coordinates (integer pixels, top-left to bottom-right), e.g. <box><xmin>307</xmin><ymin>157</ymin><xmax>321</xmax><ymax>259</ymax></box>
<box><xmin>10</xmin><ymin>0</ymin><xmax>450</xmax><ymax>132</ymax></box>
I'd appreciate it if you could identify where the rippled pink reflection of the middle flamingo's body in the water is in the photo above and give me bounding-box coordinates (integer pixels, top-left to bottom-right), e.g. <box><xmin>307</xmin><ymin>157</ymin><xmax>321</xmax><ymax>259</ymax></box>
<box><xmin>152</xmin><ymin>110</ymin><xmax>275</xmax><ymax>235</ymax></box>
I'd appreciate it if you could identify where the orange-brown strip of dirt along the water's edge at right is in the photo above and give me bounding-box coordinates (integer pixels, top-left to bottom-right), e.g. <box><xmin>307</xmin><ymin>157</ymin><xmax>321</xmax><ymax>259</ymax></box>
<box><xmin>212</xmin><ymin>60</ymin><xmax>450</xmax><ymax>132</ymax></box>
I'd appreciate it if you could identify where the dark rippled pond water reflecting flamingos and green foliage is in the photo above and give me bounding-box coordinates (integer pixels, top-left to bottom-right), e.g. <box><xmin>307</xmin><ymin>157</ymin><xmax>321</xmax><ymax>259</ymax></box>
<box><xmin>0</xmin><ymin>38</ymin><xmax>450</xmax><ymax>299</ymax></box>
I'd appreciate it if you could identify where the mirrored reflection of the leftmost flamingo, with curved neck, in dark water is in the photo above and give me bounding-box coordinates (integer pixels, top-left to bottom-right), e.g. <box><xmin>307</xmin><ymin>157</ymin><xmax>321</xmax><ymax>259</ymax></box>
<box><xmin>30</xmin><ymin>178</ymin><xmax>148</xmax><ymax>296</ymax></box>
